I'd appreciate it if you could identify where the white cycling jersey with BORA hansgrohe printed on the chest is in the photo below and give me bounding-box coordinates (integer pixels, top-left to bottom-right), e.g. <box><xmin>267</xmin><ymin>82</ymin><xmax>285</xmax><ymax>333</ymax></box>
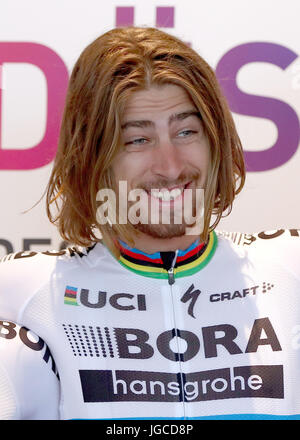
<box><xmin>0</xmin><ymin>229</ymin><xmax>300</xmax><ymax>419</ymax></box>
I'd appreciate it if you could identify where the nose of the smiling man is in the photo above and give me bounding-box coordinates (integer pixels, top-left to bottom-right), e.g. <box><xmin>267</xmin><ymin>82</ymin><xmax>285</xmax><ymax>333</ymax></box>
<box><xmin>151</xmin><ymin>138</ymin><xmax>184</xmax><ymax>181</ymax></box>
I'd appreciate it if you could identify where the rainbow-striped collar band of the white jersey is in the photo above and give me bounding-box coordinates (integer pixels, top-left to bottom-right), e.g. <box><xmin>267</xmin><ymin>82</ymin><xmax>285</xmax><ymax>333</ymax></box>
<box><xmin>119</xmin><ymin>231</ymin><xmax>218</xmax><ymax>279</ymax></box>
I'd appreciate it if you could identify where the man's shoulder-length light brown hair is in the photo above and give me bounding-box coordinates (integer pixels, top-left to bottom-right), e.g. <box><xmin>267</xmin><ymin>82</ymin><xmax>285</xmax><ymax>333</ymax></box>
<box><xmin>46</xmin><ymin>26</ymin><xmax>245</xmax><ymax>258</ymax></box>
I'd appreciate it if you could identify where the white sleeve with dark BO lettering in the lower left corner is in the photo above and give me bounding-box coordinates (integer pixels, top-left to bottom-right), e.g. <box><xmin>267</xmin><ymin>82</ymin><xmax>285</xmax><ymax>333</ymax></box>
<box><xmin>0</xmin><ymin>321</ymin><xmax>60</xmax><ymax>420</ymax></box>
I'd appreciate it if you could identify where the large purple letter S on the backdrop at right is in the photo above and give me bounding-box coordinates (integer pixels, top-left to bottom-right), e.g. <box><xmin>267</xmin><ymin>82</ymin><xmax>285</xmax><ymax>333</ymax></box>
<box><xmin>216</xmin><ymin>43</ymin><xmax>300</xmax><ymax>171</ymax></box>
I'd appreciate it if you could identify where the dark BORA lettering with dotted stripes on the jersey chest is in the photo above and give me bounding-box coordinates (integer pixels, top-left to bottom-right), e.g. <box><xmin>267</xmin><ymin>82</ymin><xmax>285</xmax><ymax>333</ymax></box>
<box><xmin>63</xmin><ymin>318</ymin><xmax>282</xmax><ymax>362</ymax></box>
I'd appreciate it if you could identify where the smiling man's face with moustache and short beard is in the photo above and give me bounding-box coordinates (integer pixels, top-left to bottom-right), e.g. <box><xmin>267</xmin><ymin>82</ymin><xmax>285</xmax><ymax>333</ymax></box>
<box><xmin>112</xmin><ymin>84</ymin><xmax>210</xmax><ymax>238</ymax></box>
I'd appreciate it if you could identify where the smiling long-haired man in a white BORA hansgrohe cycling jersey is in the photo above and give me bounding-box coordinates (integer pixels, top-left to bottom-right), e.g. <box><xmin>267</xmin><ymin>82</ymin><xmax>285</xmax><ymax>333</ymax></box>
<box><xmin>0</xmin><ymin>27</ymin><xmax>300</xmax><ymax>419</ymax></box>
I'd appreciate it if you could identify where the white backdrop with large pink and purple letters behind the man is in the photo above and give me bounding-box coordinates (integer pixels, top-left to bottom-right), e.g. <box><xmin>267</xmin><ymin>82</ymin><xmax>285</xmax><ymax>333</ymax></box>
<box><xmin>0</xmin><ymin>0</ymin><xmax>300</xmax><ymax>256</ymax></box>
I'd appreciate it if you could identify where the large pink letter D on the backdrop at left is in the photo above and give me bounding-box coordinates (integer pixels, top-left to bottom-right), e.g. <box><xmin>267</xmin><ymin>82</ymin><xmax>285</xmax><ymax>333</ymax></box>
<box><xmin>0</xmin><ymin>42</ymin><xmax>69</xmax><ymax>170</ymax></box>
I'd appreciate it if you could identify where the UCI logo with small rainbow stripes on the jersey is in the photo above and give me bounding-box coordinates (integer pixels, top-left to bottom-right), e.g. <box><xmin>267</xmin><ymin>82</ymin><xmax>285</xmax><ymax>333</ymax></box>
<box><xmin>64</xmin><ymin>286</ymin><xmax>146</xmax><ymax>311</ymax></box>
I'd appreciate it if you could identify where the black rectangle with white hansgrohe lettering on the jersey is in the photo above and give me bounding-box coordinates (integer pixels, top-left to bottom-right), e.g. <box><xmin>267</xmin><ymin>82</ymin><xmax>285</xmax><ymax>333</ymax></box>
<box><xmin>79</xmin><ymin>365</ymin><xmax>284</xmax><ymax>402</ymax></box>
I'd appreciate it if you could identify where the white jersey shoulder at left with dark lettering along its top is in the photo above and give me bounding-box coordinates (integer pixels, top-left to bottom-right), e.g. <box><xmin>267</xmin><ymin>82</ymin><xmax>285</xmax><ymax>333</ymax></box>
<box><xmin>0</xmin><ymin>245</ymin><xmax>102</xmax><ymax>323</ymax></box>
